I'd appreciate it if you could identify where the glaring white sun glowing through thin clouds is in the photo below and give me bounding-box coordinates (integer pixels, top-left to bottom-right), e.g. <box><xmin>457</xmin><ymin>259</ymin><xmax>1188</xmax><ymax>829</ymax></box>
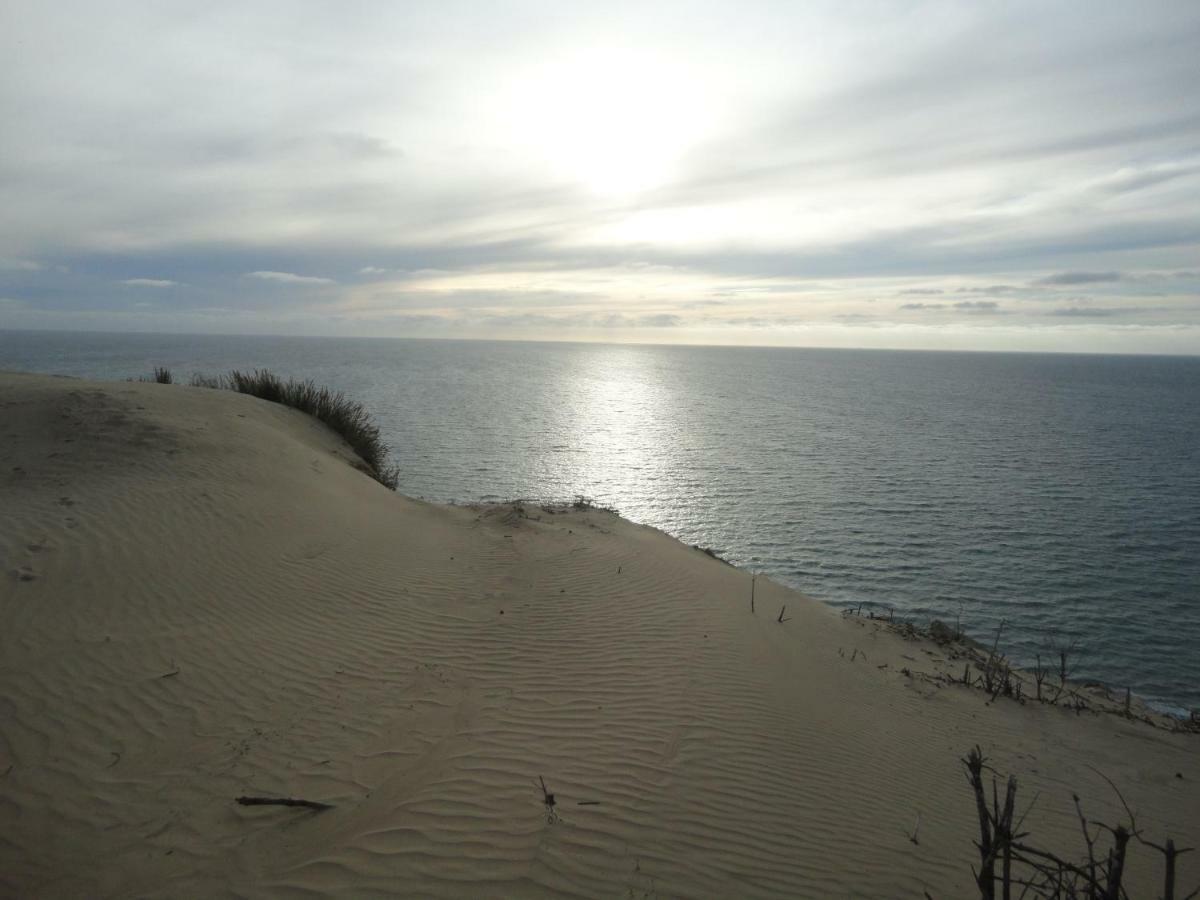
<box><xmin>511</xmin><ymin>48</ymin><xmax>704</xmax><ymax>196</ymax></box>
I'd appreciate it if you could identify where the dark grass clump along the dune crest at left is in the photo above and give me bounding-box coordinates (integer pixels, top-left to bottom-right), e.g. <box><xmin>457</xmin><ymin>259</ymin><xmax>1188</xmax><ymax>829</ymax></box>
<box><xmin>135</xmin><ymin>368</ymin><xmax>400</xmax><ymax>491</ymax></box>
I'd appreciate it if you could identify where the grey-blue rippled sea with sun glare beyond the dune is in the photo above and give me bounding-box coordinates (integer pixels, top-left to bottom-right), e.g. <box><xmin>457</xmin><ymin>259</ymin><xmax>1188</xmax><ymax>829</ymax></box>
<box><xmin>7</xmin><ymin>332</ymin><xmax>1200</xmax><ymax>710</ymax></box>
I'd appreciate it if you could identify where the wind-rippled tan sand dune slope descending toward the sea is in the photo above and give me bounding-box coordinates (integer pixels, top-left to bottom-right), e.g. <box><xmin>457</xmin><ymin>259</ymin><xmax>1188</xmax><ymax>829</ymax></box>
<box><xmin>0</xmin><ymin>376</ymin><xmax>1200</xmax><ymax>898</ymax></box>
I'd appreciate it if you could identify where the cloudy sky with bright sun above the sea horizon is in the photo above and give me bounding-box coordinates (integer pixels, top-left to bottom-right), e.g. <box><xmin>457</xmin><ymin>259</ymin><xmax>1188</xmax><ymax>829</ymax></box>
<box><xmin>0</xmin><ymin>0</ymin><xmax>1200</xmax><ymax>354</ymax></box>
